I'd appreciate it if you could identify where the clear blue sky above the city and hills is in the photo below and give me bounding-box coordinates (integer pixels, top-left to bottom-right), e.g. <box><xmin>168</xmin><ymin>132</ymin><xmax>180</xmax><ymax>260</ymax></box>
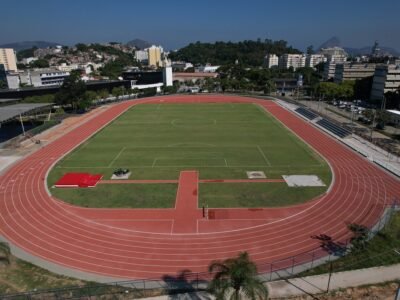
<box><xmin>0</xmin><ymin>0</ymin><xmax>400</xmax><ymax>50</ymax></box>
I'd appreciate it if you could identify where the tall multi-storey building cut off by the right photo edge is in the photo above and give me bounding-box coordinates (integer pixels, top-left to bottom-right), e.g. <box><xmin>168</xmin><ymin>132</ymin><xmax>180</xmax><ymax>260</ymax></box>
<box><xmin>371</xmin><ymin>64</ymin><xmax>400</xmax><ymax>100</ymax></box>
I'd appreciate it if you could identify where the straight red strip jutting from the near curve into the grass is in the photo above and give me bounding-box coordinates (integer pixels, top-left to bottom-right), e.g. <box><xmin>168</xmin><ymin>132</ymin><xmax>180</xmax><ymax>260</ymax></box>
<box><xmin>172</xmin><ymin>171</ymin><xmax>202</xmax><ymax>233</ymax></box>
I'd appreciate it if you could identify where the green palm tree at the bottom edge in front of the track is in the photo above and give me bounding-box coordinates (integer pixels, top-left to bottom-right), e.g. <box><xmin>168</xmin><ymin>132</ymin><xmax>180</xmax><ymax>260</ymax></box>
<box><xmin>208</xmin><ymin>252</ymin><xmax>268</xmax><ymax>300</ymax></box>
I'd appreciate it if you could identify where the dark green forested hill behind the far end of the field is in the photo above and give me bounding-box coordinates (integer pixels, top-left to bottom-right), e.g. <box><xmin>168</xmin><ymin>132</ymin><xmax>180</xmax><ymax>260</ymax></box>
<box><xmin>169</xmin><ymin>40</ymin><xmax>301</xmax><ymax>66</ymax></box>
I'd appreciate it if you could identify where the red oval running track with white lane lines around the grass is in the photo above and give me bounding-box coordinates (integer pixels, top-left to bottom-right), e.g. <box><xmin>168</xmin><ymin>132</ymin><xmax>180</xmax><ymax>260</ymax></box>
<box><xmin>0</xmin><ymin>96</ymin><xmax>400</xmax><ymax>279</ymax></box>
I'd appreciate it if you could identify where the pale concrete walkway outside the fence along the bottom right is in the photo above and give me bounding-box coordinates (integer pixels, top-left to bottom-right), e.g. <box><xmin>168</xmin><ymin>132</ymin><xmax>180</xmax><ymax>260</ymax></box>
<box><xmin>141</xmin><ymin>264</ymin><xmax>400</xmax><ymax>300</ymax></box>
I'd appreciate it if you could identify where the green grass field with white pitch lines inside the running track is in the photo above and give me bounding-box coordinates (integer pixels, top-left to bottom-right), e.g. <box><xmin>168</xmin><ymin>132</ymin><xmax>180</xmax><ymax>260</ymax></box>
<box><xmin>48</xmin><ymin>103</ymin><xmax>331</xmax><ymax>208</ymax></box>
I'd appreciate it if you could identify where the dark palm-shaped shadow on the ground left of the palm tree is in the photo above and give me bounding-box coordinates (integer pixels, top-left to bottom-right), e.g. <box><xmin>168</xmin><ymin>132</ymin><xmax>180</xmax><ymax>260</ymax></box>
<box><xmin>162</xmin><ymin>269</ymin><xmax>211</xmax><ymax>300</ymax></box>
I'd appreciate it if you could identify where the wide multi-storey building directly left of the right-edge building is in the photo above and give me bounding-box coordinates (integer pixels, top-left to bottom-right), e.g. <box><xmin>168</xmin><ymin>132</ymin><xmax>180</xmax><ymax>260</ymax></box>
<box><xmin>334</xmin><ymin>63</ymin><xmax>376</xmax><ymax>83</ymax></box>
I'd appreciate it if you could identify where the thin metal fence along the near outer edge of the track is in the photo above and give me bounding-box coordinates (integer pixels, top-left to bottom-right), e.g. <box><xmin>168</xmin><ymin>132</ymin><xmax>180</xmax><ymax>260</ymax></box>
<box><xmin>0</xmin><ymin>202</ymin><xmax>400</xmax><ymax>300</ymax></box>
